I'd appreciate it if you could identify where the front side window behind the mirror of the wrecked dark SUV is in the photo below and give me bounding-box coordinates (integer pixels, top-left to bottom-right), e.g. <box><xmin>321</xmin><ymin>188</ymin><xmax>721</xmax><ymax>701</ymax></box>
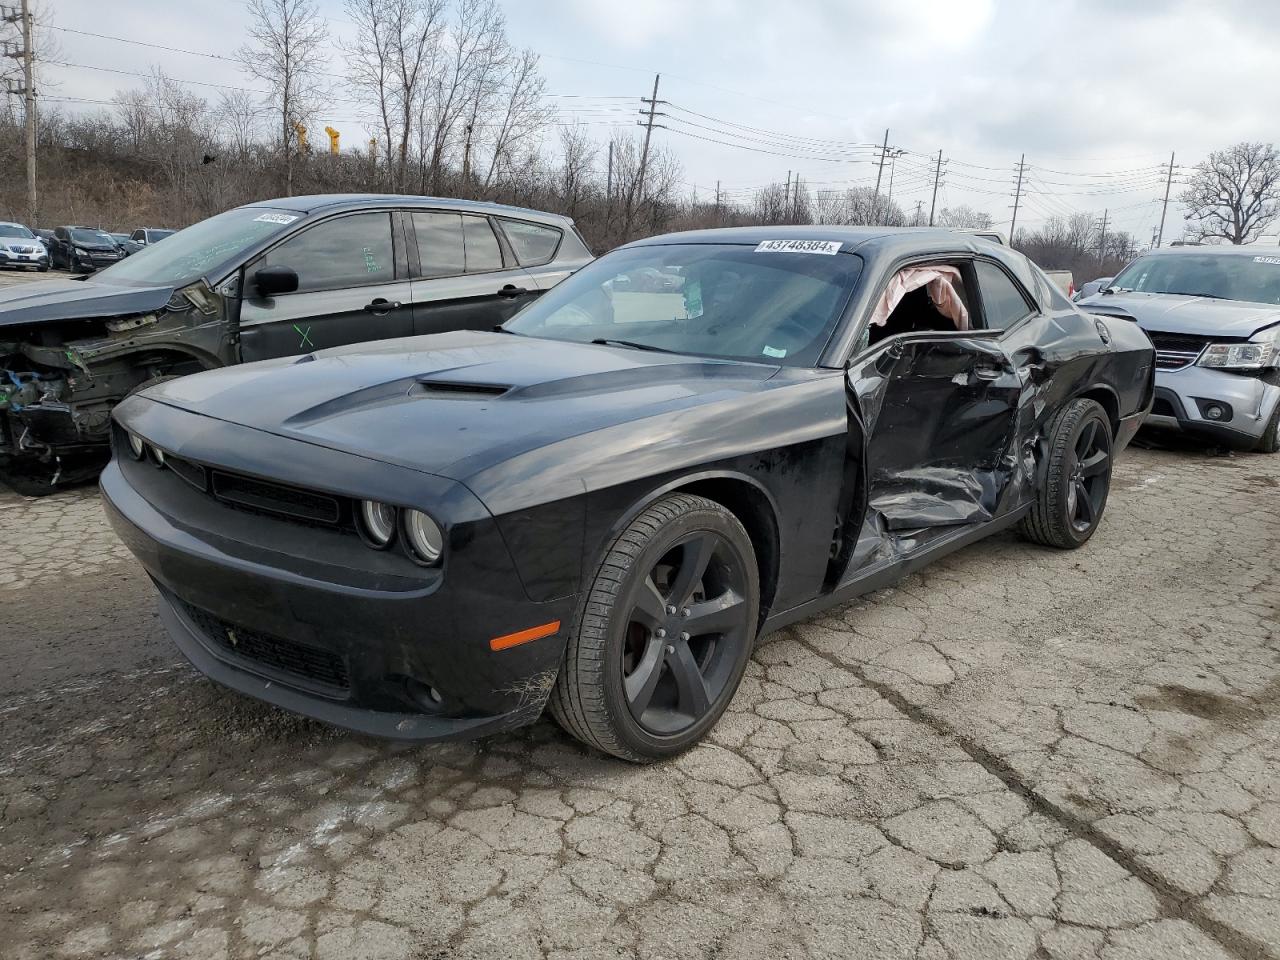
<box><xmin>253</xmin><ymin>212</ymin><xmax>396</xmax><ymax>293</ymax></box>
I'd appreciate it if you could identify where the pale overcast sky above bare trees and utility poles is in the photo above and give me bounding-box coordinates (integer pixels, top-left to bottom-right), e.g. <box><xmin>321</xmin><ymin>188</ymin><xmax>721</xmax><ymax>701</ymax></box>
<box><xmin>45</xmin><ymin>0</ymin><xmax>1280</xmax><ymax>241</ymax></box>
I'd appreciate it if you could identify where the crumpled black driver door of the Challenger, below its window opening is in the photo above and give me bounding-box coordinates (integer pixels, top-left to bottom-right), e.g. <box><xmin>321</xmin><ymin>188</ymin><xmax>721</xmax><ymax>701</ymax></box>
<box><xmin>845</xmin><ymin>330</ymin><xmax>1024</xmax><ymax>580</ymax></box>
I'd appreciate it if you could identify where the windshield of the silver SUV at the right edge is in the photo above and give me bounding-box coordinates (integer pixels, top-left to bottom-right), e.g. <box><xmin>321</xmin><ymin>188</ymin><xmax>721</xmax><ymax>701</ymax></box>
<box><xmin>1111</xmin><ymin>253</ymin><xmax>1280</xmax><ymax>303</ymax></box>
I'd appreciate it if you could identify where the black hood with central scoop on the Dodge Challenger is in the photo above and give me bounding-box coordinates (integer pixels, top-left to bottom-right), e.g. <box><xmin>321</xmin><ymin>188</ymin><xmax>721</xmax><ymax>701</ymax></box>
<box><xmin>145</xmin><ymin>332</ymin><xmax>780</xmax><ymax>480</ymax></box>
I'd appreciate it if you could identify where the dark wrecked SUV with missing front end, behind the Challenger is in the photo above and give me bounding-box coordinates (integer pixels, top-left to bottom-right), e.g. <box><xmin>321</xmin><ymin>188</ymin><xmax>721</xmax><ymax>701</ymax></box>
<box><xmin>0</xmin><ymin>195</ymin><xmax>591</xmax><ymax>495</ymax></box>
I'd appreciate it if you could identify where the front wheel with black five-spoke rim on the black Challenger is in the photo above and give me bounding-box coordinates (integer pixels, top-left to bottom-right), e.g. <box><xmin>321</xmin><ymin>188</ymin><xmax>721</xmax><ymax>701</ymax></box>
<box><xmin>548</xmin><ymin>494</ymin><xmax>760</xmax><ymax>763</ymax></box>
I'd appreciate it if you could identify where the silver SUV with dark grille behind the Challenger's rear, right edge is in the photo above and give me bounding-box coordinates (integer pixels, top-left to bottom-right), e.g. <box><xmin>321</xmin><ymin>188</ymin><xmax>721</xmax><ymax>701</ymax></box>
<box><xmin>1079</xmin><ymin>246</ymin><xmax>1280</xmax><ymax>453</ymax></box>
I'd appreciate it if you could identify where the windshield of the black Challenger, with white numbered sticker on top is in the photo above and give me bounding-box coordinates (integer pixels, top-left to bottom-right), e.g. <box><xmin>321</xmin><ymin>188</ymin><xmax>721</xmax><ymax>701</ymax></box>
<box><xmin>504</xmin><ymin>243</ymin><xmax>863</xmax><ymax>366</ymax></box>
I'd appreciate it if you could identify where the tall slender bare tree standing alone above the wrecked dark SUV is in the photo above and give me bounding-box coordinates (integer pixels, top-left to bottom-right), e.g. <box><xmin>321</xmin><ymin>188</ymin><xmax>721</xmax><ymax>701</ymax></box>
<box><xmin>236</xmin><ymin>0</ymin><xmax>329</xmax><ymax>196</ymax></box>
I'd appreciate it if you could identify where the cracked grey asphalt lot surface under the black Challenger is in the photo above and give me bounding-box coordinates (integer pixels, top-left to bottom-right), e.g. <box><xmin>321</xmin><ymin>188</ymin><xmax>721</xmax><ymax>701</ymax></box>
<box><xmin>0</xmin><ymin>448</ymin><xmax>1280</xmax><ymax>960</ymax></box>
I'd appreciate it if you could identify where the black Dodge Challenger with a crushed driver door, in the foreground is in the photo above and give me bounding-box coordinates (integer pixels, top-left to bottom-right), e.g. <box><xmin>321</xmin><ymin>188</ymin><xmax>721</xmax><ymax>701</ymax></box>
<box><xmin>101</xmin><ymin>227</ymin><xmax>1153</xmax><ymax>760</ymax></box>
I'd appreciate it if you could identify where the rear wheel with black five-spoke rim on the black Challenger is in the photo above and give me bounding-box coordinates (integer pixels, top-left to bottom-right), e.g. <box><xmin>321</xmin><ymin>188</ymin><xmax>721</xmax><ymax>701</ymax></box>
<box><xmin>1019</xmin><ymin>399</ymin><xmax>1112</xmax><ymax>550</ymax></box>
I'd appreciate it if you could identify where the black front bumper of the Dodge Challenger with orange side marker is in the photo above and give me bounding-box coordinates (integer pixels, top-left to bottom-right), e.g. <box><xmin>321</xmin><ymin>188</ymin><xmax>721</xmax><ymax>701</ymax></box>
<box><xmin>101</xmin><ymin>417</ymin><xmax>576</xmax><ymax>741</ymax></box>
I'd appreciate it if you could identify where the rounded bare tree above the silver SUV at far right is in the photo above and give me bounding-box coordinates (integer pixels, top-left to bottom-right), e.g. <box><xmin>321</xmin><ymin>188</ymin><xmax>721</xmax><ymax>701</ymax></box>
<box><xmin>1180</xmin><ymin>143</ymin><xmax>1280</xmax><ymax>243</ymax></box>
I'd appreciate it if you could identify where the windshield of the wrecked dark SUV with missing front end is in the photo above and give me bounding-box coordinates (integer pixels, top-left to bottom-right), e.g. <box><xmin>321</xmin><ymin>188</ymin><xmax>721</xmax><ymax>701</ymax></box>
<box><xmin>96</xmin><ymin>207</ymin><xmax>302</xmax><ymax>287</ymax></box>
